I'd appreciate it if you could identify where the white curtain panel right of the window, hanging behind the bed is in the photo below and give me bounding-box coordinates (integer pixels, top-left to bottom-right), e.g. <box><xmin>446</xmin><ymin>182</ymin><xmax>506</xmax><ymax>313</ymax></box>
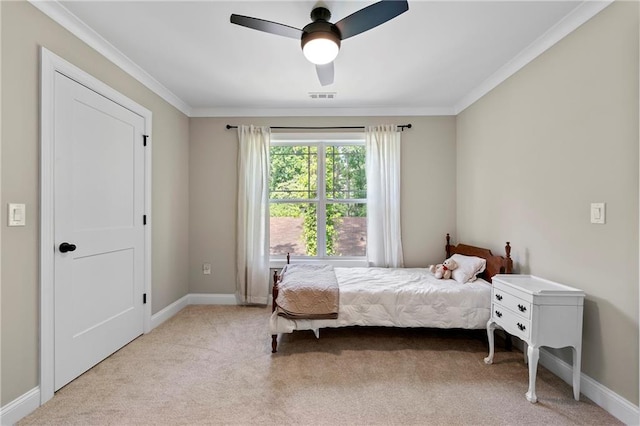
<box><xmin>366</xmin><ymin>125</ymin><xmax>404</xmax><ymax>268</ymax></box>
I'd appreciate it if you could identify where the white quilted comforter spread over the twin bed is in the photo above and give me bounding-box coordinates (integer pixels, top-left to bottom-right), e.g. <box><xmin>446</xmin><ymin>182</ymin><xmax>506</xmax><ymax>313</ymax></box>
<box><xmin>270</xmin><ymin>268</ymin><xmax>491</xmax><ymax>334</ymax></box>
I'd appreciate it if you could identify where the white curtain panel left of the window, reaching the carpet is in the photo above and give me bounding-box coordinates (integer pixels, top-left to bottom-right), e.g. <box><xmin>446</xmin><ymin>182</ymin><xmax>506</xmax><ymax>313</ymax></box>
<box><xmin>236</xmin><ymin>126</ymin><xmax>271</xmax><ymax>304</ymax></box>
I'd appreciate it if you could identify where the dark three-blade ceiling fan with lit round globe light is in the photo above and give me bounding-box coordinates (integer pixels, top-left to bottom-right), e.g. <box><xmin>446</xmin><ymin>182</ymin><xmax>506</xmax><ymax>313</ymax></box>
<box><xmin>231</xmin><ymin>0</ymin><xmax>409</xmax><ymax>86</ymax></box>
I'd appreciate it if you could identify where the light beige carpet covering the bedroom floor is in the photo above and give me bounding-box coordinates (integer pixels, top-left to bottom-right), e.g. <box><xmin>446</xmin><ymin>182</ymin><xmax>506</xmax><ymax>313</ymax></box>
<box><xmin>19</xmin><ymin>306</ymin><xmax>620</xmax><ymax>425</ymax></box>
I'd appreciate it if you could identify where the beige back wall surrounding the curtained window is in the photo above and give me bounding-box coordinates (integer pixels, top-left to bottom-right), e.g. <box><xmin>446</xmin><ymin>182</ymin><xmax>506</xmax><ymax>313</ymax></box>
<box><xmin>189</xmin><ymin>117</ymin><xmax>456</xmax><ymax>294</ymax></box>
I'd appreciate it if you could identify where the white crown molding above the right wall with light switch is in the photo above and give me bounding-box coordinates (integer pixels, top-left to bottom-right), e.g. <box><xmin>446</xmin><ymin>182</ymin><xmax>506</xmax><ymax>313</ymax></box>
<box><xmin>453</xmin><ymin>0</ymin><xmax>614</xmax><ymax>115</ymax></box>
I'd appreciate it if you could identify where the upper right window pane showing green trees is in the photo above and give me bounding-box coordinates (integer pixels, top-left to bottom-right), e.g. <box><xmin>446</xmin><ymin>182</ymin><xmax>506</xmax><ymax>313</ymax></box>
<box><xmin>325</xmin><ymin>145</ymin><xmax>367</xmax><ymax>200</ymax></box>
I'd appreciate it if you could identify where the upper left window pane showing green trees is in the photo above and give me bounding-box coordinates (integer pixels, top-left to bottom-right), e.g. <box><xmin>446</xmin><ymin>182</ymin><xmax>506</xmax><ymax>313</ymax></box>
<box><xmin>269</xmin><ymin>146</ymin><xmax>318</xmax><ymax>200</ymax></box>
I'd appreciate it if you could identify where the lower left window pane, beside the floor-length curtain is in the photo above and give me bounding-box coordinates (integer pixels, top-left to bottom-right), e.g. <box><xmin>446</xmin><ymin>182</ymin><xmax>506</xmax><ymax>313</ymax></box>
<box><xmin>269</xmin><ymin>203</ymin><xmax>318</xmax><ymax>256</ymax></box>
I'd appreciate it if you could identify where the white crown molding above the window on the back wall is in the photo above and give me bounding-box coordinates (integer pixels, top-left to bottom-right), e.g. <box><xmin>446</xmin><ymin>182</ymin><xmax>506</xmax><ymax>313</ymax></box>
<box><xmin>191</xmin><ymin>107</ymin><xmax>455</xmax><ymax>117</ymax></box>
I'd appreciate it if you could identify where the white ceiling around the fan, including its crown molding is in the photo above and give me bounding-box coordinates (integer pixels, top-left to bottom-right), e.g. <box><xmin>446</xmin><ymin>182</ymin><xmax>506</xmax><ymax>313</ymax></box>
<box><xmin>37</xmin><ymin>0</ymin><xmax>610</xmax><ymax>116</ymax></box>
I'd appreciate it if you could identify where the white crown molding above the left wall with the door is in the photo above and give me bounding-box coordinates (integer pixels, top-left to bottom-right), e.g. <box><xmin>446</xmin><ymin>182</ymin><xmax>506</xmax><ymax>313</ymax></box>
<box><xmin>29</xmin><ymin>0</ymin><xmax>191</xmax><ymax>116</ymax></box>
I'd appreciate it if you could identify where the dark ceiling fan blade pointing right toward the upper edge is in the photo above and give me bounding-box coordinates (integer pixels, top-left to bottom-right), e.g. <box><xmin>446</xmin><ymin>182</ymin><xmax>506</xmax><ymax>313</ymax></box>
<box><xmin>336</xmin><ymin>0</ymin><xmax>409</xmax><ymax>40</ymax></box>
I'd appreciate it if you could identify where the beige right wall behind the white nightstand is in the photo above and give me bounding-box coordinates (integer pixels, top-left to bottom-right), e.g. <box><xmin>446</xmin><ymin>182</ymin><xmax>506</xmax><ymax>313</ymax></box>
<box><xmin>457</xmin><ymin>2</ymin><xmax>638</xmax><ymax>405</ymax></box>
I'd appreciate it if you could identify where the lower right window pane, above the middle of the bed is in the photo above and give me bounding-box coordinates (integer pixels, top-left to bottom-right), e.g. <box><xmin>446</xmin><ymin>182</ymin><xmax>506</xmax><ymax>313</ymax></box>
<box><xmin>327</xmin><ymin>203</ymin><xmax>367</xmax><ymax>256</ymax></box>
